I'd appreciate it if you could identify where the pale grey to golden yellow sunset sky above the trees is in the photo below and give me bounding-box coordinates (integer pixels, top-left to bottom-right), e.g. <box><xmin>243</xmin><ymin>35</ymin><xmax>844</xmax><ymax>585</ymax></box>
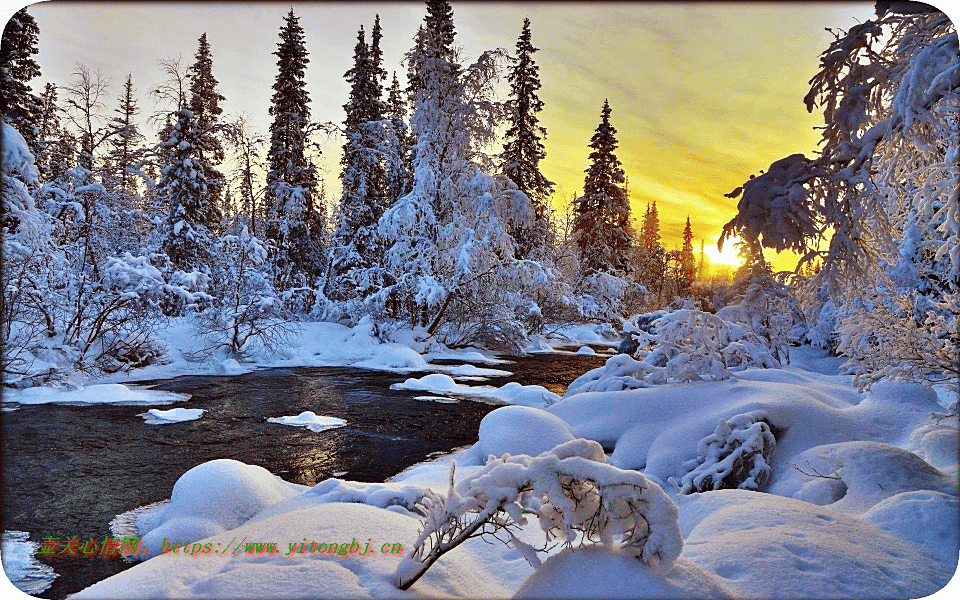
<box><xmin>13</xmin><ymin>2</ymin><xmax>873</xmax><ymax>268</ymax></box>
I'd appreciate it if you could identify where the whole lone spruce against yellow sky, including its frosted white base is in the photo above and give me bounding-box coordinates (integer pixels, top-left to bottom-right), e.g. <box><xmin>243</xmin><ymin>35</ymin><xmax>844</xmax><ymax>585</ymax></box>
<box><xmin>573</xmin><ymin>100</ymin><xmax>633</xmax><ymax>319</ymax></box>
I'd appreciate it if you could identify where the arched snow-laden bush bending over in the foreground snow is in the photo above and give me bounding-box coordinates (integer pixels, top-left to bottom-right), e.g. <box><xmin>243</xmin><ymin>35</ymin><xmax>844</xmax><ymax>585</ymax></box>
<box><xmin>394</xmin><ymin>439</ymin><xmax>683</xmax><ymax>590</ymax></box>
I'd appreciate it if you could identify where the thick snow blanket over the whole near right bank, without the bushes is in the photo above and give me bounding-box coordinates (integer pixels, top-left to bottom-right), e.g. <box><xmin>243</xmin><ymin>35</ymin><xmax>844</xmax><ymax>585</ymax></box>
<box><xmin>69</xmin><ymin>350</ymin><xmax>960</xmax><ymax>598</ymax></box>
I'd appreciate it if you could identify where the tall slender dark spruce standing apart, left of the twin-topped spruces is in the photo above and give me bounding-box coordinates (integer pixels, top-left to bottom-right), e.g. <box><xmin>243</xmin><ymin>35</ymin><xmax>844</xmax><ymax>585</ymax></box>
<box><xmin>265</xmin><ymin>9</ymin><xmax>324</xmax><ymax>292</ymax></box>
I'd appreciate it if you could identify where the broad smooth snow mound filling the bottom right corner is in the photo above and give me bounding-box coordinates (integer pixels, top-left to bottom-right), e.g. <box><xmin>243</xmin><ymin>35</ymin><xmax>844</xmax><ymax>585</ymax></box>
<box><xmin>679</xmin><ymin>490</ymin><xmax>956</xmax><ymax>598</ymax></box>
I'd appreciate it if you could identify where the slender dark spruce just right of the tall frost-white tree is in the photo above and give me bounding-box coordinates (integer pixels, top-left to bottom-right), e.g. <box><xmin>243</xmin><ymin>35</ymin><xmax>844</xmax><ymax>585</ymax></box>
<box><xmin>500</xmin><ymin>19</ymin><xmax>553</xmax><ymax>258</ymax></box>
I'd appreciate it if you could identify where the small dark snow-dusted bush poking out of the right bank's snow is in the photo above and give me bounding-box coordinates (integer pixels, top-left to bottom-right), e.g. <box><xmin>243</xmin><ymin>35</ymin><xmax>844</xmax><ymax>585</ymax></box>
<box><xmin>680</xmin><ymin>413</ymin><xmax>777</xmax><ymax>494</ymax></box>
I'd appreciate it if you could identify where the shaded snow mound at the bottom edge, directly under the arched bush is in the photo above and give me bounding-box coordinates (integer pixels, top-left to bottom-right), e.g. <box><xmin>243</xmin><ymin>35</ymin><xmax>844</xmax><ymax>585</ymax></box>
<box><xmin>514</xmin><ymin>547</ymin><xmax>733</xmax><ymax>599</ymax></box>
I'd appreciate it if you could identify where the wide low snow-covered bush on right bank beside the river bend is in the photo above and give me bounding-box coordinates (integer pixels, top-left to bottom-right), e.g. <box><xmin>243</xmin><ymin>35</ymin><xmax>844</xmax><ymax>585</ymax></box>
<box><xmin>566</xmin><ymin>307</ymin><xmax>780</xmax><ymax>396</ymax></box>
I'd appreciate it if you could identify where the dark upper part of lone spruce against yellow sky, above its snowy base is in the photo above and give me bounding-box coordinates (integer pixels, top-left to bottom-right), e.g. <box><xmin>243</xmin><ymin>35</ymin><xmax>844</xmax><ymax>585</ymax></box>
<box><xmin>573</xmin><ymin>100</ymin><xmax>631</xmax><ymax>275</ymax></box>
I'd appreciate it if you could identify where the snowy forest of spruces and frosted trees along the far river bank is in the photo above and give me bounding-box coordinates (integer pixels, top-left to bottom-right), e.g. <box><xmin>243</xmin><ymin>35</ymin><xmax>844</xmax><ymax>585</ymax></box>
<box><xmin>0</xmin><ymin>0</ymin><xmax>756</xmax><ymax>378</ymax></box>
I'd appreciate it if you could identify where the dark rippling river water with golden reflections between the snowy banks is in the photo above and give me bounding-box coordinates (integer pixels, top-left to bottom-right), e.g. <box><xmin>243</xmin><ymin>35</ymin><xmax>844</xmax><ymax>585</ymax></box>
<box><xmin>0</xmin><ymin>354</ymin><xmax>606</xmax><ymax>600</ymax></box>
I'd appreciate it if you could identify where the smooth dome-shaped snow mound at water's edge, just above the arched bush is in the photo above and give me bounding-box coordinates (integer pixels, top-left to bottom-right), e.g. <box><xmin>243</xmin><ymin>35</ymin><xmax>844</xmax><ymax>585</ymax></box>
<box><xmin>479</xmin><ymin>406</ymin><xmax>576</xmax><ymax>456</ymax></box>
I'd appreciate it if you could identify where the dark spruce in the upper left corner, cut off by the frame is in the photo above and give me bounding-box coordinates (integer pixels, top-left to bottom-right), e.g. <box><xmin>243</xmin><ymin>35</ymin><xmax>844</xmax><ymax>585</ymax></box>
<box><xmin>0</xmin><ymin>8</ymin><xmax>41</xmax><ymax>152</ymax></box>
